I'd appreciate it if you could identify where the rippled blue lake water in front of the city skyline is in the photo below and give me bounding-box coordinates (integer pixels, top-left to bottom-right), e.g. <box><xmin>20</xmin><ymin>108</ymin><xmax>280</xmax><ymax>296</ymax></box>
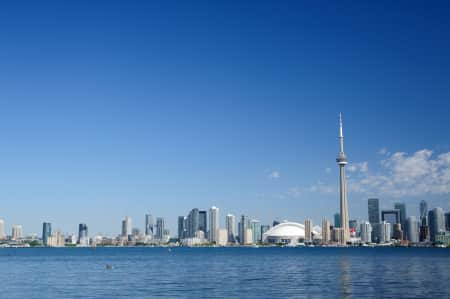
<box><xmin>0</xmin><ymin>248</ymin><xmax>450</xmax><ymax>298</ymax></box>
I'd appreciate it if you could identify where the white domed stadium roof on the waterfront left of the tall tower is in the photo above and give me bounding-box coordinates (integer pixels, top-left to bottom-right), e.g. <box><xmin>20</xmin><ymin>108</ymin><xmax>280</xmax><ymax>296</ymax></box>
<box><xmin>263</xmin><ymin>222</ymin><xmax>316</xmax><ymax>244</ymax></box>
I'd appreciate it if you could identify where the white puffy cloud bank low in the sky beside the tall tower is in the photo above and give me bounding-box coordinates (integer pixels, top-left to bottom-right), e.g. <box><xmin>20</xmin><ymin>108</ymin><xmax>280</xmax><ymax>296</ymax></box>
<box><xmin>288</xmin><ymin>149</ymin><xmax>450</xmax><ymax>198</ymax></box>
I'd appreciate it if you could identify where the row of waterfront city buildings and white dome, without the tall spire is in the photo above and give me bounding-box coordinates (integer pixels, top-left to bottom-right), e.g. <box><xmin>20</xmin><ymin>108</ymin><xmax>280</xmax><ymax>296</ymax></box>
<box><xmin>0</xmin><ymin>193</ymin><xmax>450</xmax><ymax>247</ymax></box>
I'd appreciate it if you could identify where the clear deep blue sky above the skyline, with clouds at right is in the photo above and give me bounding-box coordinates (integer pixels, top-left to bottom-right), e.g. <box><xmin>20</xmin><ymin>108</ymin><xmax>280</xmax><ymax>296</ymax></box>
<box><xmin>0</xmin><ymin>1</ymin><xmax>450</xmax><ymax>235</ymax></box>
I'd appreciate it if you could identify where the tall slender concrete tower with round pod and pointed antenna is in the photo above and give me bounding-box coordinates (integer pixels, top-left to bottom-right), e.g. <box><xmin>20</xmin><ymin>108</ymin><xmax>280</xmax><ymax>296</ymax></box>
<box><xmin>336</xmin><ymin>113</ymin><xmax>350</xmax><ymax>243</ymax></box>
